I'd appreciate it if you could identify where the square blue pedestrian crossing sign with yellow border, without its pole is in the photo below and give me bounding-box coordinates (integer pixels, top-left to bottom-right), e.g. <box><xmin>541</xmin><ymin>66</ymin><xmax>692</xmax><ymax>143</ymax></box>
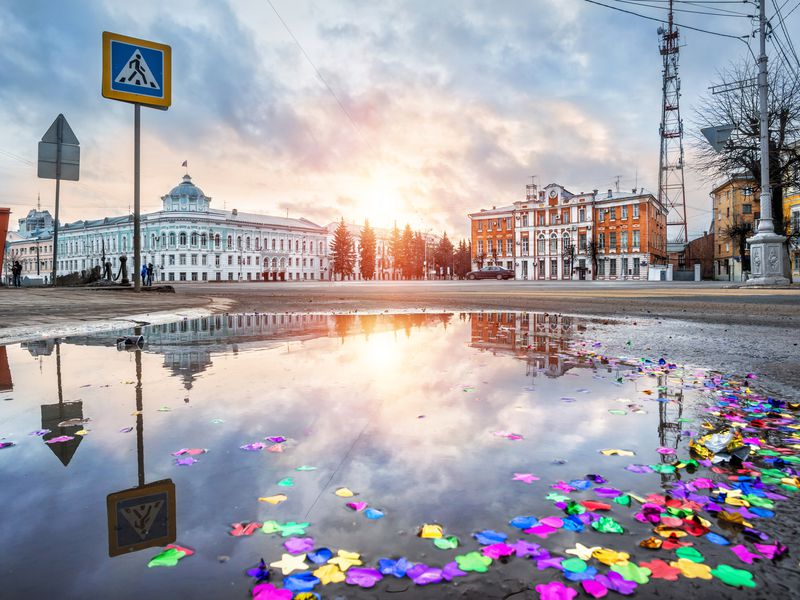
<box><xmin>103</xmin><ymin>31</ymin><xmax>172</xmax><ymax>110</ymax></box>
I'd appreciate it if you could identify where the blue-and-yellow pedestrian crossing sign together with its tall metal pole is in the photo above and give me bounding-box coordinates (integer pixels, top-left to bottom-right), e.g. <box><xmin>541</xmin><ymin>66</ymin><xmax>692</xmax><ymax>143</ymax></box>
<box><xmin>103</xmin><ymin>31</ymin><xmax>172</xmax><ymax>292</ymax></box>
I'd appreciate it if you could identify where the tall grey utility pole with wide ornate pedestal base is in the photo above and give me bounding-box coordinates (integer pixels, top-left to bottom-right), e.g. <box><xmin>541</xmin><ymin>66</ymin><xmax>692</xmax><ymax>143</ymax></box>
<box><xmin>746</xmin><ymin>0</ymin><xmax>789</xmax><ymax>286</ymax></box>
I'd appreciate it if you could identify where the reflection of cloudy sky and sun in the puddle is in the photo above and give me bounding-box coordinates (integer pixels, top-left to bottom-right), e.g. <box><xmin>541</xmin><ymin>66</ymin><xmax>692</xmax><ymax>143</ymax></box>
<box><xmin>0</xmin><ymin>315</ymin><xmax>692</xmax><ymax>595</ymax></box>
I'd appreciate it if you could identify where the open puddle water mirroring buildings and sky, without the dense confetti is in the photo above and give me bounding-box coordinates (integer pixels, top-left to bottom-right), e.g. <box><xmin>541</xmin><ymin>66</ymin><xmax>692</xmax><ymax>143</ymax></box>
<box><xmin>0</xmin><ymin>313</ymin><xmax>700</xmax><ymax>598</ymax></box>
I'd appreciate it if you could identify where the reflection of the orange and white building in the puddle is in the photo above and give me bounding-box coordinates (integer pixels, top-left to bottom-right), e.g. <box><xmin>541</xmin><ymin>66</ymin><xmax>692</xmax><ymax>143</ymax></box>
<box><xmin>470</xmin><ymin>312</ymin><xmax>588</xmax><ymax>377</ymax></box>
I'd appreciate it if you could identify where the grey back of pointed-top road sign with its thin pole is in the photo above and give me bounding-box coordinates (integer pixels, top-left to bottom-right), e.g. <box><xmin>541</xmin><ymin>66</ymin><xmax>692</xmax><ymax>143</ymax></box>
<box><xmin>38</xmin><ymin>115</ymin><xmax>81</xmax><ymax>287</ymax></box>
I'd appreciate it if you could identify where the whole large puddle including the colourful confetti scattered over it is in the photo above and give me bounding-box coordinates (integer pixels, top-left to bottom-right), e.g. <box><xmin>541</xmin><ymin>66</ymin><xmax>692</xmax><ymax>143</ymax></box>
<box><xmin>0</xmin><ymin>313</ymin><xmax>800</xmax><ymax>598</ymax></box>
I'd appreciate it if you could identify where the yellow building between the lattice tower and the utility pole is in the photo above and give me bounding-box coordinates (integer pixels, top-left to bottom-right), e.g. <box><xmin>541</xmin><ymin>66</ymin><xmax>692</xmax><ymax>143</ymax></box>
<box><xmin>711</xmin><ymin>175</ymin><xmax>761</xmax><ymax>281</ymax></box>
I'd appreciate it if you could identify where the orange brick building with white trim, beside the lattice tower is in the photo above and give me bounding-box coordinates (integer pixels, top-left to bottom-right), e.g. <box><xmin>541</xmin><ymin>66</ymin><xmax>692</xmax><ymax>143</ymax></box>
<box><xmin>469</xmin><ymin>183</ymin><xmax>667</xmax><ymax>281</ymax></box>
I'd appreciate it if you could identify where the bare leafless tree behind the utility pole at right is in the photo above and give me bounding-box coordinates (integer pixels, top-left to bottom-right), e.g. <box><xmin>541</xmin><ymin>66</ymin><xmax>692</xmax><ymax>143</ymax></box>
<box><xmin>692</xmin><ymin>59</ymin><xmax>800</xmax><ymax>232</ymax></box>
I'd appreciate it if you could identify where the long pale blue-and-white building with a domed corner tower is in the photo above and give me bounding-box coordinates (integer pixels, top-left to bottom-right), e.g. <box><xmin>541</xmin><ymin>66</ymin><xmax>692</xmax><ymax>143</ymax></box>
<box><xmin>57</xmin><ymin>174</ymin><xmax>328</xmax><ymax>282</ymax></box>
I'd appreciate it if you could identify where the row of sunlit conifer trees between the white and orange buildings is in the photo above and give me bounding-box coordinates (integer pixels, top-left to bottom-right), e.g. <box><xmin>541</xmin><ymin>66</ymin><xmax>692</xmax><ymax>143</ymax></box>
<box><xmin>330</xmin><ymin>217</ymin><xmax>471</xmax><ymax>280</ymax></box>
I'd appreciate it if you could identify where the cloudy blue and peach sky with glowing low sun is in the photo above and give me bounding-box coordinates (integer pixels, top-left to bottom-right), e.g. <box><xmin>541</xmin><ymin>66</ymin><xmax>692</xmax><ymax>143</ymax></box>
<box><xmin>0</xmin><ymin>0</ymin><xmax>800</xmax><ymax>238</ymax></box>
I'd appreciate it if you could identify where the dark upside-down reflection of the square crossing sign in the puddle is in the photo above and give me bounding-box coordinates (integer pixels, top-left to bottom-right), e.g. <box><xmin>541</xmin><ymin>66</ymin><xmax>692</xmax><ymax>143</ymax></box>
<box><xmin>106</xmin><ymin>479</ymin><xmax>176</xmax><ymax>556</ymax></box>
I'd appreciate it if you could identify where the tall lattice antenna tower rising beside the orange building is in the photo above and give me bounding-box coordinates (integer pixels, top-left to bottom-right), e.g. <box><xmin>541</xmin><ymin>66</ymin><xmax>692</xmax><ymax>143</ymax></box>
<box><xmin>658</xmin><ymin>0</ymin><xmax>689</xmax><ymax>243</ymax></box>
